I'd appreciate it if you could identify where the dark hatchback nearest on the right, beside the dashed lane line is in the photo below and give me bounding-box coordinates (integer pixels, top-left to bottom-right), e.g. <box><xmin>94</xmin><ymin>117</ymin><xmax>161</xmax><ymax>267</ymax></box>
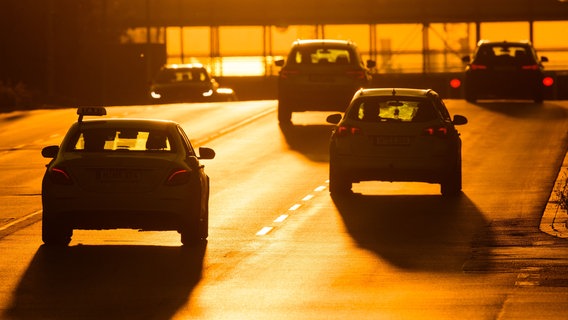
<box><xmin>327</xmin><ymin>88</ymin><xmax>467</xmax><ymax>196</ymax></box>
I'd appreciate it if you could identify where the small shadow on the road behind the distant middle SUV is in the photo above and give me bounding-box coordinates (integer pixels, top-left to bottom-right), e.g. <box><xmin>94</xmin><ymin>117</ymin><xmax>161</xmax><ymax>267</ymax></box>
<box><xmin>280</xmin><ymin>124</ymin><xmax>333</xmax><ymax>162</ymax></box>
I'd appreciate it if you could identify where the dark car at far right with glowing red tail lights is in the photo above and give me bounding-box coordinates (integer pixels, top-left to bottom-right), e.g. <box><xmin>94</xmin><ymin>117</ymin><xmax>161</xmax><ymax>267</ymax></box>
<box><xmin>462</xmin><ymin>40</ymin><xmax>548</xmax><ymax>103</ymax></box>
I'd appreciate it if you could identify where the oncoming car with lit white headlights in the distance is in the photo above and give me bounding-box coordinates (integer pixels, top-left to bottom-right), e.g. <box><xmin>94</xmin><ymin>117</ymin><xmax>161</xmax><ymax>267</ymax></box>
<box><xmin>150</xmin><ymin>64</ymin><xmax>237</xmax><ymax>103</ymax></box>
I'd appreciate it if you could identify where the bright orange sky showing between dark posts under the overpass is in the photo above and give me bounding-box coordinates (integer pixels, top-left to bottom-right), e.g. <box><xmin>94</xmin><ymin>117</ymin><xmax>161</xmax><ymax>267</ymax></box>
<box><xmin>161</xmin><ymin>21</ymin><xmax>568</xmax><ymax>74</ymax></box>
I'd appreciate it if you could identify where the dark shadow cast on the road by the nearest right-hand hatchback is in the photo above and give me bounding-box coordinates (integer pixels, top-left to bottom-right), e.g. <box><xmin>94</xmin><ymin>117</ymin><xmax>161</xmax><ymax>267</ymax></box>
<box><xmin>332</xmin><ymin>194</ymin><xmax>492</xmax><ymax>273</ymax></box>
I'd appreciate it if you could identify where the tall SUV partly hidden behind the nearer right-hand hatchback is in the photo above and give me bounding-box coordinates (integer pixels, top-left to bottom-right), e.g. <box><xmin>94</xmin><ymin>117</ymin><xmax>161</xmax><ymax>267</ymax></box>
<box><xmin>275</xmin><ymin>39</ymin><xmax>376</xmax><ymax>124</ymax></box>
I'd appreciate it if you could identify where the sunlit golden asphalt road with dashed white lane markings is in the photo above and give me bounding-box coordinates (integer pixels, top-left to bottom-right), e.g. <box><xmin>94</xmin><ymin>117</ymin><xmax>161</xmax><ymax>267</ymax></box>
<box><xmin>0</xmin><ymin>100</ymin><xmax>568</xmax><ymax>319</ymax></box>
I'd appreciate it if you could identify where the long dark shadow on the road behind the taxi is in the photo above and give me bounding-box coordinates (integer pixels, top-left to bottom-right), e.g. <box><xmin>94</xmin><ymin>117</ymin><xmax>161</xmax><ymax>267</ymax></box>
<box><xmin>2</xmin><ymin>244</ymin><xmax>206</xmax><ymax>319</ymax></box>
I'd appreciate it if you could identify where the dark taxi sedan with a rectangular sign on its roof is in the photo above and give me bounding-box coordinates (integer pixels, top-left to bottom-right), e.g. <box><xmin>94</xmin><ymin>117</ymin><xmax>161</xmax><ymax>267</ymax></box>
<box><xmin>42</xmin><ymin>108</ymin><xmax>215</xmax><ymax>246</ymax></box>
